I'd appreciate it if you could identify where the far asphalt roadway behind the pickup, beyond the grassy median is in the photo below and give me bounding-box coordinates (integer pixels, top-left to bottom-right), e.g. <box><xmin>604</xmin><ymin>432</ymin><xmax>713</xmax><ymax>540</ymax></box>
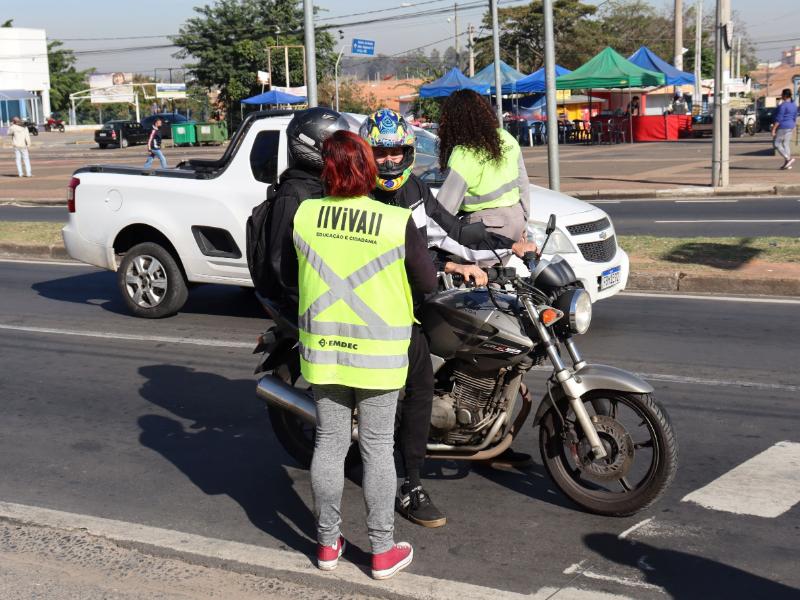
<box><xmin>0</xmin><ymin>197</ymin><xmax>800</xmax><ymax>237</ymax></box>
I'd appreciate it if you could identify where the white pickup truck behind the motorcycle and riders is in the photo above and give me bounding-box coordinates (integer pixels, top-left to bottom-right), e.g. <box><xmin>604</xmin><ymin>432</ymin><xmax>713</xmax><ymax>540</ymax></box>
<box><xmin>62</xmin><ymin>111</ymin><xmax>629</xmax><ymax>318</ymax></box>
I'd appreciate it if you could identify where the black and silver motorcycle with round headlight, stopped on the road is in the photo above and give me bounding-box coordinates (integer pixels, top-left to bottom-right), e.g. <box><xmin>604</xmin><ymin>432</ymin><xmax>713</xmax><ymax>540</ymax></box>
<box><xmin>254</xmin><ymin>215</ymin><xmax>678</xmax><ymax>516</ymax></box>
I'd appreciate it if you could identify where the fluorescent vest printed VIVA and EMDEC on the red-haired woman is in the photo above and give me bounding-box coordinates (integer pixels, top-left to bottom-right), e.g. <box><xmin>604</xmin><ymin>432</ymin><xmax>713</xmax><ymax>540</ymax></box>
<box><xmin>293</xmin><ymin>197</ymin><xmax>414</xmax><ymax>390</ymax></box>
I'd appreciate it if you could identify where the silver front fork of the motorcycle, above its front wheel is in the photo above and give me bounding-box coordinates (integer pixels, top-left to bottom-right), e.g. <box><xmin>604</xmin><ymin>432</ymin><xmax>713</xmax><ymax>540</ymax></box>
<box><xmin>522</xmin><ymin>298</ymin><xmax>607</xmax><ymax>459</ymax></box>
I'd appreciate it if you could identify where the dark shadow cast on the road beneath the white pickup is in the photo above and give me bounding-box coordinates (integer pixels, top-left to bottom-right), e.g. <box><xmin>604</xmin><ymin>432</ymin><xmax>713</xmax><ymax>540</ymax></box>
<box><xmin>31</xmin><ymin>271</ymin><xmax>265</xmax><ymax>318</ymax></box>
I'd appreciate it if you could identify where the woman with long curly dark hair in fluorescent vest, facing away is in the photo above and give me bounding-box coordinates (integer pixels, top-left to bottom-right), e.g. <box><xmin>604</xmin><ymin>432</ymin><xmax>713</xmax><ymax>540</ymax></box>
<box><xmin>436</xmin><ymin>90</ymin><xmax>529</xmax><ymax>240</ymax></box>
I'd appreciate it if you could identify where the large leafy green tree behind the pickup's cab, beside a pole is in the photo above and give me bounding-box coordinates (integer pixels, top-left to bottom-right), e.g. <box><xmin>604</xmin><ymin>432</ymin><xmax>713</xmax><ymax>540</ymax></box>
<box><xmin>172</xmin><ymin>0</ymin><xmax>336</xmax><ymax>120</ymax></box>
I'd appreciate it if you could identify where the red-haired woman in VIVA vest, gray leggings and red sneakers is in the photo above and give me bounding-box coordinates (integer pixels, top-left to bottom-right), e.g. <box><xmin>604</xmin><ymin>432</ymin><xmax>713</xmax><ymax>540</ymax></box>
<box><xmin>284</xmin><ymin>131</ymin><xmax>436</xmax><ymax>579</ymax></box>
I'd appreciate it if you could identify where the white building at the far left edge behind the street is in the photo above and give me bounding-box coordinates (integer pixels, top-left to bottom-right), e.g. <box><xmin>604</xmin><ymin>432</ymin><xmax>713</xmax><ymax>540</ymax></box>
<box><xmin>0</xmin><ymin>27</ymin><xmax>51</xmax><ymax>124</ymax></box>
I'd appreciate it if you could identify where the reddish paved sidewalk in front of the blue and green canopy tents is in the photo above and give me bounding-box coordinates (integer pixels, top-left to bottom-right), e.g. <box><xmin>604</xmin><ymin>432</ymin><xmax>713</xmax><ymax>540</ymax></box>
<box><xmin>523</xmin><ymin>133</ymin><xmax>800</xmax><ymax>200</ymax></box>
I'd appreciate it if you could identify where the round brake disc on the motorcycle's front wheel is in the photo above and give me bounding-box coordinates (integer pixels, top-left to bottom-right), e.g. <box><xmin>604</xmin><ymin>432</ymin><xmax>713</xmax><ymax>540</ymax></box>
<box><xmin>577</xmin><ymin>415</ymin><xmax>634</xmax><ymax>481</ymax></box>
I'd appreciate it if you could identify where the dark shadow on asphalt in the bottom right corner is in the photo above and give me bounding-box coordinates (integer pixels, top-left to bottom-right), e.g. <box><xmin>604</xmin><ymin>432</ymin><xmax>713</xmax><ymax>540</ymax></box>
<box><xmin>584</xmin><ymin>533</ymin><xmax>800</xmax><ymax>600</ymax></box>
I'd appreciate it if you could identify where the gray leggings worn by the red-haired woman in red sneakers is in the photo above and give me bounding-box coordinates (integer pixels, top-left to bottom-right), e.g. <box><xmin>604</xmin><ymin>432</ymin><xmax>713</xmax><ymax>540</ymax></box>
<box><xmin>311</xmin><ymin>385</ymin><xmax>399</xmax><ymax>554</ymax></box>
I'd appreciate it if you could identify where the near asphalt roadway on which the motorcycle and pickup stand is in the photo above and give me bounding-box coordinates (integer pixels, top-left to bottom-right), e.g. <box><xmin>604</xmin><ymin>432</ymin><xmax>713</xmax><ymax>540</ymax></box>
<box><xmin>0</xmin><ymin>262</ymin><xmax>800</xmax><ymax>598</ymax></box>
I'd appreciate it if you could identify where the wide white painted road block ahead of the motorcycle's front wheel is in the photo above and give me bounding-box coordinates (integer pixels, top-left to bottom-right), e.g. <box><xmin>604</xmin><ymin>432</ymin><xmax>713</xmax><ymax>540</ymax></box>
<box><xmin>682</xmin><ymin>442</ymin><xmax>800</xmax><ymax>519</ymax></box>
